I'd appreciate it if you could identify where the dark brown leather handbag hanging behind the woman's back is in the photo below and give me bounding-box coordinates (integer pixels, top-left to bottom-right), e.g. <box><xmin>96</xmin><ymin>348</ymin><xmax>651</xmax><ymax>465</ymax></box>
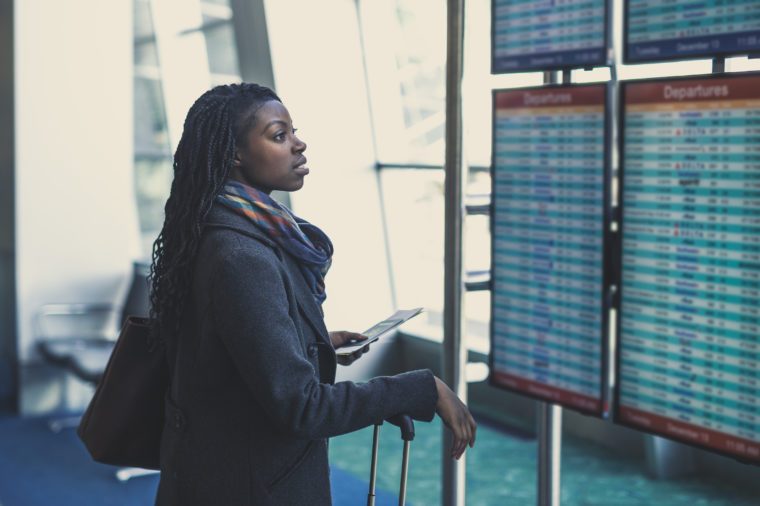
<box><xmin>77</xmin><ymin>316</ymin><xmax>169</xmax><ymax>469</ymax></box>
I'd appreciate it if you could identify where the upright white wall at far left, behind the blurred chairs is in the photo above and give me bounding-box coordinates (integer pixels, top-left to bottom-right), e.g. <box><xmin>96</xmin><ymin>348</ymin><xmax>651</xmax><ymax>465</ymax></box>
<box><xmin>15</xmin><ymin>0</ymin><xmax>139</xmax><ymax>363</ymax></box>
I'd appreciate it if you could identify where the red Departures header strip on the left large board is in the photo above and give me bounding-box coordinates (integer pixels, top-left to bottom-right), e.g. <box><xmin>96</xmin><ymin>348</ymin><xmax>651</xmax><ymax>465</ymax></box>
<box><xmin>495</xmin><ymin>84</ymin><xmax>607</xmax><ymax>109</ymax></box>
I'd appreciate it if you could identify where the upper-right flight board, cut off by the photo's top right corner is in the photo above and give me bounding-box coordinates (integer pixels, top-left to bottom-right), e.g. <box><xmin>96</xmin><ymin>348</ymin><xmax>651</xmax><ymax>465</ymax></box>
<box><xmin>623</xmin><ymin>0</ymin><xmax>760</xmax><ymax>63</ymax></box>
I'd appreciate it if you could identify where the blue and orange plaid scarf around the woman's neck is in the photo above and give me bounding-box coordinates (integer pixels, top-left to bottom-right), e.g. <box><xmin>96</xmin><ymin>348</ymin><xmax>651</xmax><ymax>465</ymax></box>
<box><xmin>216</xmin><ymin>180</ymin><xmax>333</xmax><ymax>304</ymax></box>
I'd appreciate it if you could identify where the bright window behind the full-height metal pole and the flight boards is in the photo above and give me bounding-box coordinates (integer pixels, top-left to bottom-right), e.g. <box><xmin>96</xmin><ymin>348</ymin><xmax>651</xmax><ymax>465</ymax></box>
<box><xmin>359</xmin><ymin>0</ymin><xmax>760</xmax><ymax>352</ymax></box>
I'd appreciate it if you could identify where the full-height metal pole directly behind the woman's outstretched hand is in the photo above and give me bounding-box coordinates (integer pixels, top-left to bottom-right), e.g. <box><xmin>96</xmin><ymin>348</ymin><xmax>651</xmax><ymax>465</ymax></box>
<box><xmin>442</xmin><ymin>0</ymin><xmax>467</xmax><ymax>506</ymax></box>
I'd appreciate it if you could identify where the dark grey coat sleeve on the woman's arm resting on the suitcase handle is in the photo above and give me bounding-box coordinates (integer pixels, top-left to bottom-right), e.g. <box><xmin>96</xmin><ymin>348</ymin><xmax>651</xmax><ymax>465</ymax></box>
<box><xmin>211</xmin><ymin>245</ymin><xmax>438</xmax><ymax>439</ymax></box>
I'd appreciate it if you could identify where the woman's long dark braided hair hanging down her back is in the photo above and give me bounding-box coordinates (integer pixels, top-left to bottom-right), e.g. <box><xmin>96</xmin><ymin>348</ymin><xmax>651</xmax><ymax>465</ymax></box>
<box><xmin>149</xmin><ymin>83</ymin><xmax>281</xmax><ymax>339</ymax></box>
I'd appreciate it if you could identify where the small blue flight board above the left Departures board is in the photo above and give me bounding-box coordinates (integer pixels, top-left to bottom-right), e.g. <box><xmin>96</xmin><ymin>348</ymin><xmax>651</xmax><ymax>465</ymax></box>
<box><xmin>491</xmin><ymin>0</ymin><xmax>609</xmax><ymax>74</ymax></box>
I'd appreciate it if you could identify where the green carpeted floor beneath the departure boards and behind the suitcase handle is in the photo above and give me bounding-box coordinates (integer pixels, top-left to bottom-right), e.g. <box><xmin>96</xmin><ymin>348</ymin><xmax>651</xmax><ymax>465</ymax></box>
<box><xmin>330</xmin><ymin>418</ymin><xmax>760</xmax><ymax>506</ymax></box>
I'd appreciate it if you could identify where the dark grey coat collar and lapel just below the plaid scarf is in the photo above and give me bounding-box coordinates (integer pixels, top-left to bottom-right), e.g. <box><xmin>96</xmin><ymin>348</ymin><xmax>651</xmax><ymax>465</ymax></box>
<box><xmin>204</xmin><ymin>205</ymin><xmax>332</xmax><ymax>346</ymax></box>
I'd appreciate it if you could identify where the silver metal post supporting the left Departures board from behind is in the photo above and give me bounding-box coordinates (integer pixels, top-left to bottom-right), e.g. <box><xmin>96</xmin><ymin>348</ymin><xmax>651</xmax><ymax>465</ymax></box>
<box><xmin>538</xmin><ymin>71</ymin><xmax>570</xmax><ymax>506</ymax></box>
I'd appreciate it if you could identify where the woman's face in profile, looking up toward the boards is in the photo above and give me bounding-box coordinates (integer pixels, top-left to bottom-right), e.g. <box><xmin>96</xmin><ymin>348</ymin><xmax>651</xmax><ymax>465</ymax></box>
<box><xmin>230</xmin><ymin>100</ymin><xmax>309</xmax><ymax>193</ymax></box>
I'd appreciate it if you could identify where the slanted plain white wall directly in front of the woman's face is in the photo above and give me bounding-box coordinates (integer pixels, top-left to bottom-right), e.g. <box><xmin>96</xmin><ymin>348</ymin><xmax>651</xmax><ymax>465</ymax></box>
<box><xmin>265</xmin><ymin>0</ymin><xmax>392</xmax><ymax>340</ymax></box>
